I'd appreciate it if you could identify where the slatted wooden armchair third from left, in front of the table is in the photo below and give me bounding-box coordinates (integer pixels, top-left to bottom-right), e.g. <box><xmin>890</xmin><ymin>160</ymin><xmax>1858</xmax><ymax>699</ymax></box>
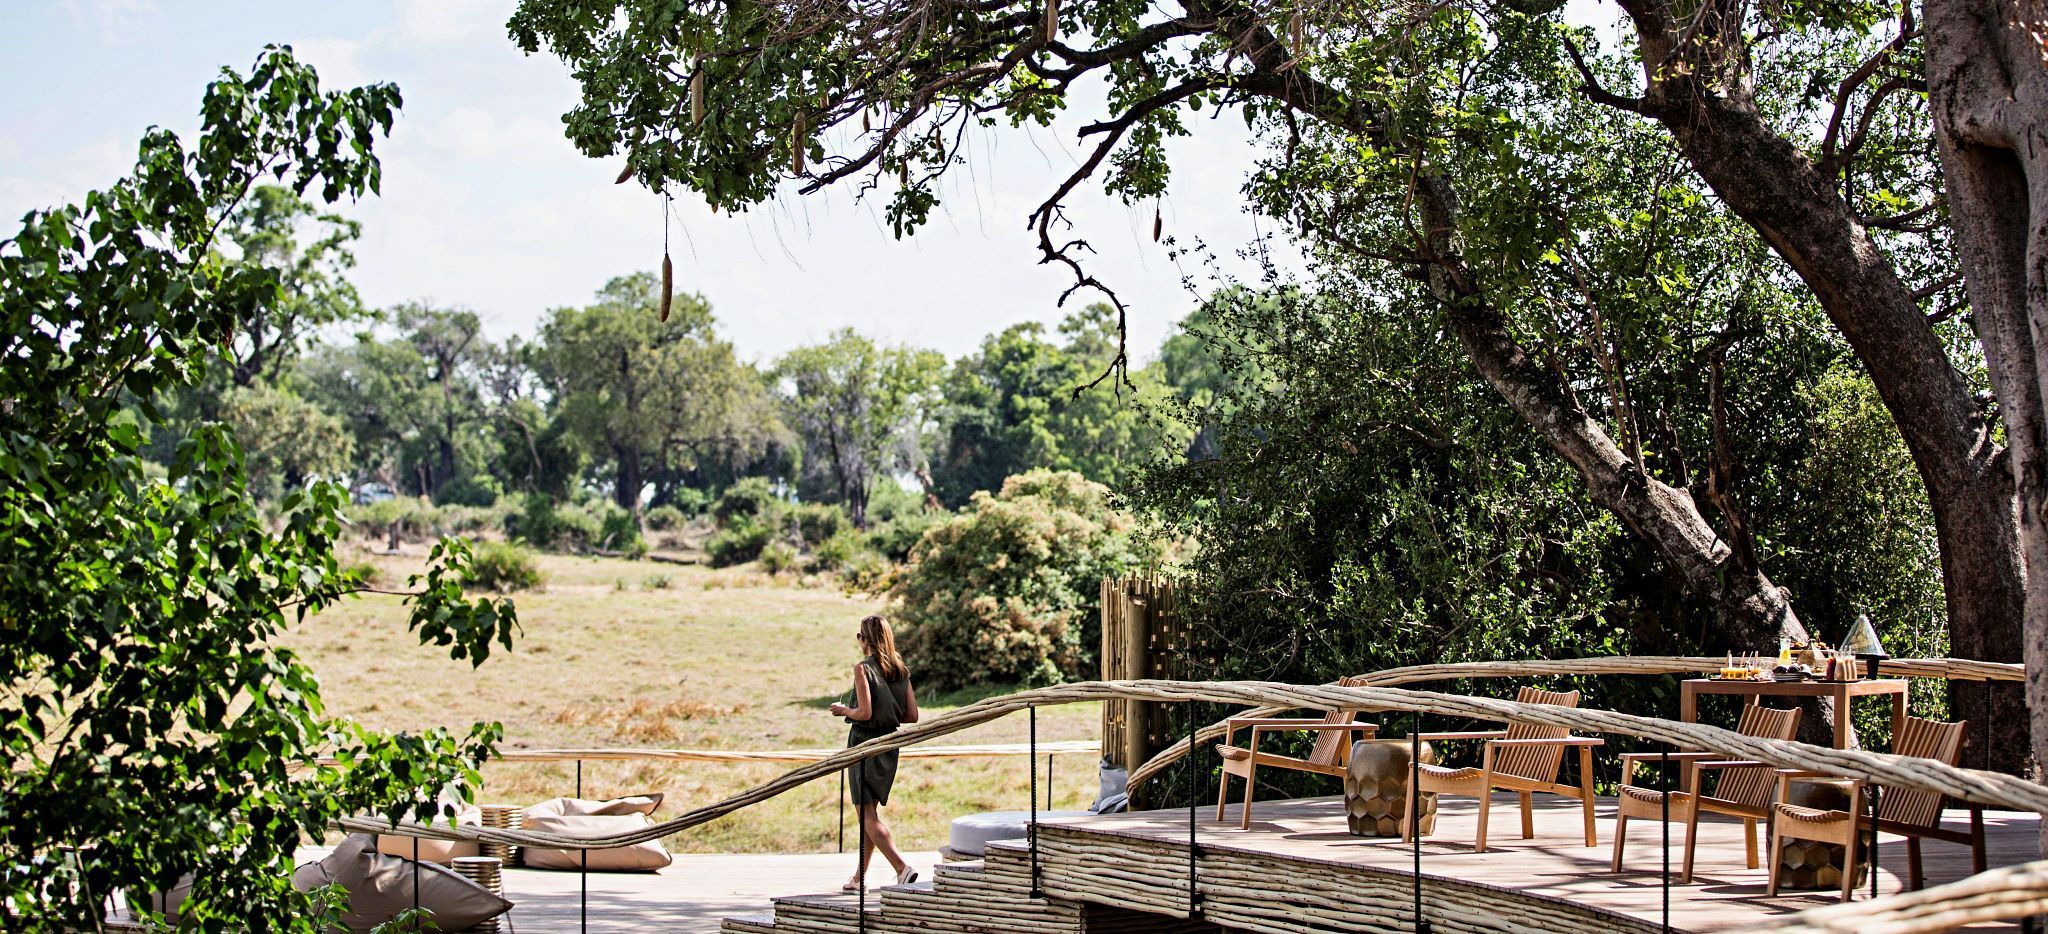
<box><xmin>1614</xmin><ymin>705</ymin><xmax>1800</xmax><ymax>883</ymax></box>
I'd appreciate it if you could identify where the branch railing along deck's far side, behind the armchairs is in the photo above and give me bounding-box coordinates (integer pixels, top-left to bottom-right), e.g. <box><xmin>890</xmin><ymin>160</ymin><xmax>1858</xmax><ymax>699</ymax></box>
<box><xmin>1130</xmin><ymin>655</ymin><xmax>2028</xmax><ymax>789</ymax></box>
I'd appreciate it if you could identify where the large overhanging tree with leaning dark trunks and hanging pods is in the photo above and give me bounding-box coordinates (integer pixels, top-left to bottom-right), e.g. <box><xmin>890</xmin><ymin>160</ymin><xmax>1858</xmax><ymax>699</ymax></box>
<box><xmin>510</xmin><ymin>0</ymin><xmax>2015</xmax><ymax>768</ymax></box>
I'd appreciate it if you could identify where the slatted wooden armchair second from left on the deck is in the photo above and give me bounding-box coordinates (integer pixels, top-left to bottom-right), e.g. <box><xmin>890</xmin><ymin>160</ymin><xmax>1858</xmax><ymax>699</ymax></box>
<box><xmin>1411</xmin><ymin>688</ymin><xmax>1606</xmax><ymax>852</ymax></box>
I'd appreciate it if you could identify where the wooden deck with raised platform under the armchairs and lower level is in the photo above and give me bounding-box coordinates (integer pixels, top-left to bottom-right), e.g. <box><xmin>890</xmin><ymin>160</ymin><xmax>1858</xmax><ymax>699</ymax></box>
<box><xmin>235</xmin><ymin>795</ymin><xmax>2038</xmax><ymax>934</ymax></box>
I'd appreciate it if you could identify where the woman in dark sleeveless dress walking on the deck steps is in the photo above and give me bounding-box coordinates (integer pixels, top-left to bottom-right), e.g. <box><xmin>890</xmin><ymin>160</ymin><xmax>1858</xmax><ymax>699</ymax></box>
<box><xmin>831</xmin><ymin>617</ymin><xmax>918</xmax><ymax>891</ymax></box>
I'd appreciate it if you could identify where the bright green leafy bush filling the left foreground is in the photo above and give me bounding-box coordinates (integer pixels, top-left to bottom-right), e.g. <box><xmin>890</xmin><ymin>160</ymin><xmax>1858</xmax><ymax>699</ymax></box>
<box><xmin>0</xmin><ymin>47</ymin><xmax>516</xmax><ymax>932</ymax></box>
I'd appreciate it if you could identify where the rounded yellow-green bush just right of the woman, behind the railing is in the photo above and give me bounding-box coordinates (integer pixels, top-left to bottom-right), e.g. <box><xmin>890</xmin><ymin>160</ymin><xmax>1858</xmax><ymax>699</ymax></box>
<box><xmin>889</xmin><ymin>471</ymin><xmax>1157</xmax><ymax>690</ymax></box>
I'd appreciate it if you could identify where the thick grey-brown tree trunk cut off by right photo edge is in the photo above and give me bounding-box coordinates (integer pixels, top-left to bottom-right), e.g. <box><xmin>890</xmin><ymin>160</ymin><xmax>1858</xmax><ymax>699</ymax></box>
<box><xmin>1925</xmin><ymin>0</ymin><xmax>2048</xmax><ymax>802</ymax></box>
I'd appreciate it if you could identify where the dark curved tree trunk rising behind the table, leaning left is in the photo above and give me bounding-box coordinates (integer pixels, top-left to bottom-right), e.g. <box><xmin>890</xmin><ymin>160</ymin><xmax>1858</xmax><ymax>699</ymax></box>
<box><xmin>1622</xmin><ymin>0</ymin><xmax>2038</xmax><ymax>772</ymax></box>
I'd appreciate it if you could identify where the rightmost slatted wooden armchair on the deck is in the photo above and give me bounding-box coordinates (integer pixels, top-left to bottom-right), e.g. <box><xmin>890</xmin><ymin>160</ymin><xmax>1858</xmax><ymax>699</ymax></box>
<box><xmin>1769</xmin><ymin>717</ymin><xmax>1985</xmax><ymax>901</ymax></box>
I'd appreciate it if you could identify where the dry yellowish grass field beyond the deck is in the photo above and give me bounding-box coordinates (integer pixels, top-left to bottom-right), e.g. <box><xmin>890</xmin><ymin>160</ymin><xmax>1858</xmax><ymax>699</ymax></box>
<box><xmin>289</xmin><ymin>555</ymin><xmax>1100</xmax><ymax>852</ymax></box>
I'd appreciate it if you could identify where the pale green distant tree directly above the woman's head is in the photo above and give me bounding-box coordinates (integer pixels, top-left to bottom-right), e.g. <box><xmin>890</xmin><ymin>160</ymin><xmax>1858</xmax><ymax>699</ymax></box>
<box><xmin>774</xmin><ymin>328</ymin><xmax>946</xmax><ymax>528</ymax></box>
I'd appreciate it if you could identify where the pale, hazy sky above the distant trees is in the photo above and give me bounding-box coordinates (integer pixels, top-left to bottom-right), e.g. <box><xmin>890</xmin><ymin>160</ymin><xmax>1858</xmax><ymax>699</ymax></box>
<box><xmin>0</xmin><ymin>0</ymin><xmax>1292</xmax><ymax>360</ymax></box>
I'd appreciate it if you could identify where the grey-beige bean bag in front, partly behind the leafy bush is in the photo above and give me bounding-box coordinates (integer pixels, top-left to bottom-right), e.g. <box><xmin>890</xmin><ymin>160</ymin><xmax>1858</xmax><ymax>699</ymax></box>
<box><xmin>291</xmin><ymin>834</ymin><xmax>512</xmax><ymax>932</ymax></box>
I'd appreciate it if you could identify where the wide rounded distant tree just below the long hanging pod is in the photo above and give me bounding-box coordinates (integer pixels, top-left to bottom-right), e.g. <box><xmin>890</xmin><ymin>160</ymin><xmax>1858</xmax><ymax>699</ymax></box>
<box><xmin>532</xmin><ymin>272</ymin><xmax>782</xmax><ymax>514</ymax></box>
